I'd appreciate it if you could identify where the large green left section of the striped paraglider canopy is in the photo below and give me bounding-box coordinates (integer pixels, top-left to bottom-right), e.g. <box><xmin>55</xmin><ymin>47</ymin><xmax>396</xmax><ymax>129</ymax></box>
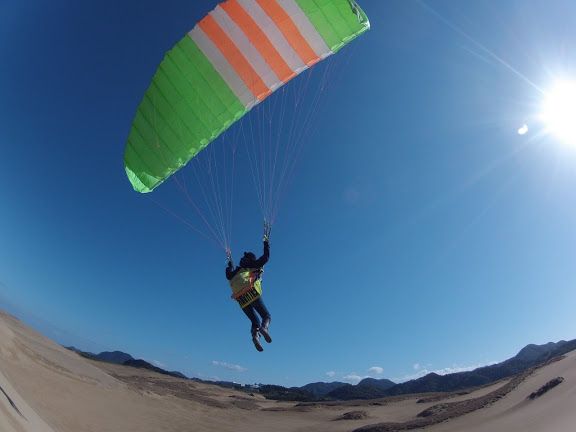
<box><xmin>124</xmin><ymin>36</ymin><xmax>247</xmax><ymax>192</ymax></box>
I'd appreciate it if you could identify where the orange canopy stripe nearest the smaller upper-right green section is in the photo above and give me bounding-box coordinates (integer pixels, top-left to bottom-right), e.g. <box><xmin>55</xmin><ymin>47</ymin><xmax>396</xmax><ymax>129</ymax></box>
<box><xmin>256</xmin><ymin>0</ymin><xmax>320</xmax><ymax>66</ymax></box>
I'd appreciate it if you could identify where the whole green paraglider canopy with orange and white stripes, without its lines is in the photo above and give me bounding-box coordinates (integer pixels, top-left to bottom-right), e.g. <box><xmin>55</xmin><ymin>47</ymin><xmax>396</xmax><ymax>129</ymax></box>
<box><xmin>124</xmin><ymin>0</ymin><xmax>370</xmax><ymax>192</ymax></box>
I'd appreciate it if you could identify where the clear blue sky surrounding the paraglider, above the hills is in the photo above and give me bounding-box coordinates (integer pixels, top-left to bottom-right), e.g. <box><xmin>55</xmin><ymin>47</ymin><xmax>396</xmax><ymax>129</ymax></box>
<box><xmin>0</xmin><ymin>0</ymin><xmax>576</xmax><ymax>385</ymax></box>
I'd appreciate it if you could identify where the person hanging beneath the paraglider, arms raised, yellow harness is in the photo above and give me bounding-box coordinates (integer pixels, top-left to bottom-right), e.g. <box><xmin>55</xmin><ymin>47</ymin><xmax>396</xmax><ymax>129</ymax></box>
<box><xmin>226</xmin><ymin>223</ymin><xmax>272</xmax><ymax>351</ymax></box>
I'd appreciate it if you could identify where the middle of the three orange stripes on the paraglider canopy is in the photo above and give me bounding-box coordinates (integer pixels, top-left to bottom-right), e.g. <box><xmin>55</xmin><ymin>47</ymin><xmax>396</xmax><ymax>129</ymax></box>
<box><xmin>220</xmin><ymin>0</ymin><xmax>296</xmax><ymax>82</ymax></box>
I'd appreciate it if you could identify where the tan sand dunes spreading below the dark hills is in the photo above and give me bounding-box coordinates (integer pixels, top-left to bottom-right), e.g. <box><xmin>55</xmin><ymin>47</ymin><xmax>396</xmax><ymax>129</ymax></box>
<box><xmin>0</xmin><ymin>312</ymin><xmax>576</xmax><ymax>432</ymax></box>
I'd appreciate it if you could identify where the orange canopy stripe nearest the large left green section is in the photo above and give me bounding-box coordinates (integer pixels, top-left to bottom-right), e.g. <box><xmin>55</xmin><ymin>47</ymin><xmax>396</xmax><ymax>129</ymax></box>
<box><xmin>198</xmin><ymin>15</ymin><xmax>272</xmax><ymax>101</ymax></box>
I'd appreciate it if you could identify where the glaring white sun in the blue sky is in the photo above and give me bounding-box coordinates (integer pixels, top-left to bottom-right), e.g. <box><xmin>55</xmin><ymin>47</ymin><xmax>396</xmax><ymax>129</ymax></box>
<box><xmin>541</xmin><ymin>80</ymin><xmax>576</xmax><ymax>147</ymax></box>
